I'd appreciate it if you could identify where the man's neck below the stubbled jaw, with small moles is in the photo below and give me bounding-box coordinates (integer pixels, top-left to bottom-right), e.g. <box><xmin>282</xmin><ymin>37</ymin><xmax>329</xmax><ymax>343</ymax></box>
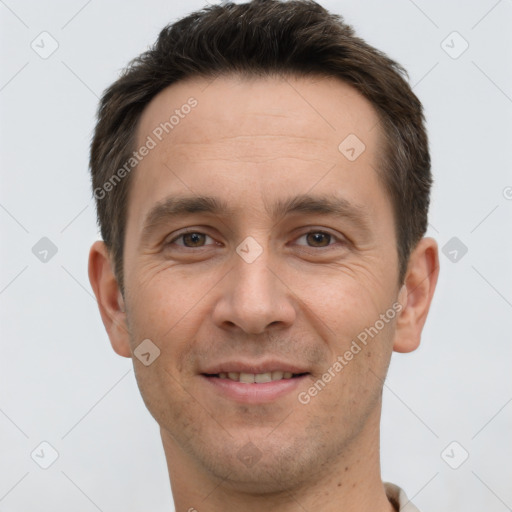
<box><xmin>161</xmin><ymin>407</ymin><xmax>395</xmax><ymax>512</ymax></box>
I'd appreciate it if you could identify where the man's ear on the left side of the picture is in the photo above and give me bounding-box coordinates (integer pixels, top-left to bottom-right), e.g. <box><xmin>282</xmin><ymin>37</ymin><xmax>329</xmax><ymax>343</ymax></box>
<box><xmin>89</xmin><ymin>241</ymin><xmax>131</xmax><ymax>357</ymax></box>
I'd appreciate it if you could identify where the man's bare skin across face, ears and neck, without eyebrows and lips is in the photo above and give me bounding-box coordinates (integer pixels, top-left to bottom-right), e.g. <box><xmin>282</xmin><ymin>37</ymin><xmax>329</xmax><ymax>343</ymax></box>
<box><xmin>89</xmin><ymin>76</ymin><xmax>439</xmax><ymax>512</ymax></box>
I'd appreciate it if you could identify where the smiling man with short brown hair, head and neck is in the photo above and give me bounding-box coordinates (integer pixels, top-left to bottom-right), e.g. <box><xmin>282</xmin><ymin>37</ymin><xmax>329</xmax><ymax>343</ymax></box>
<box><xmin>89</xmin><ymin>0</ymin><xmax>439</xmax><ymax>512</ymax></box>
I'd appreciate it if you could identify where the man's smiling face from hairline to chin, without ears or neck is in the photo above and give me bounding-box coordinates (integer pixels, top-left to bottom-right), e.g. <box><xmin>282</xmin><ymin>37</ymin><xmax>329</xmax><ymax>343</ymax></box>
<box><xmin>120</xmin><ymin>77</ymin><xmax>399</xmax><ymax>489</ymax></box>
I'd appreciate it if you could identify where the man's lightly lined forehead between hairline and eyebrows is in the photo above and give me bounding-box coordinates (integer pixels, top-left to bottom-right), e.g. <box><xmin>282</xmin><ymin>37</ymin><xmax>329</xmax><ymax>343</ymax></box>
<box><xmin>129</xmin><ymin>72</ymin><xmax>388</xmax><ymax>230</ymax></box>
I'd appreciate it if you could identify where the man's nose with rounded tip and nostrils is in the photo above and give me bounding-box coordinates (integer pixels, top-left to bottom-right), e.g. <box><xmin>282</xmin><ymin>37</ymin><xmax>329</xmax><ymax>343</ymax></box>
<box><xmin>213</xmin><ymin>242</ymin><xmax>296</xmax><ymax>334</ymax></box>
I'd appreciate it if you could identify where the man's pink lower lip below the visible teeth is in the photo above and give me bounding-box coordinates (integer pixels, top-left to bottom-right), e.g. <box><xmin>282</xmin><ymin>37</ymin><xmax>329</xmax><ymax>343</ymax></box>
<box><xmin>201</xmin><ymin>375</ymin><xmax>308</xmax><ymax>404</ymax></box>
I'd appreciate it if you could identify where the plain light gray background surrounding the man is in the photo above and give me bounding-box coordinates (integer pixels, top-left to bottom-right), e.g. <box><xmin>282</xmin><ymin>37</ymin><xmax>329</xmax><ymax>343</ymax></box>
<box><xmin>0</xmin><ymin>0</ymin><xmax>512</xmax><ymax>512</ymax></box>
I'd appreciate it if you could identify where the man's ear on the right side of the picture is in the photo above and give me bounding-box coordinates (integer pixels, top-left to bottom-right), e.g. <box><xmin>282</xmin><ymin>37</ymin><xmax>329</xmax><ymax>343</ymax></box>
<box><xmin>393</xmin><ymin>237</ymin><xmax>439</xmax><ymax>352</ymax></box>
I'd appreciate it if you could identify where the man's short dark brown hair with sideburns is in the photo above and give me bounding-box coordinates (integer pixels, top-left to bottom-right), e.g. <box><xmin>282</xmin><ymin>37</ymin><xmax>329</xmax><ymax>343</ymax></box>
<box><xmin>90</xmin><ymin>0</ymin><xmax>432</xmax><ymax>291</ymax></box>
